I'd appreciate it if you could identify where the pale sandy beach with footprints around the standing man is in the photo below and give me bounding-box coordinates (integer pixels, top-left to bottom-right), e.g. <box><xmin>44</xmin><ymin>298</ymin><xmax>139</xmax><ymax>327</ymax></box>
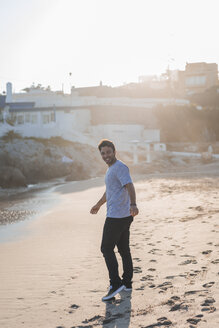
<box><xmin>0</xmin><ymin>171</ymin><xmax>219</xmax><ymax>328</ymax></box>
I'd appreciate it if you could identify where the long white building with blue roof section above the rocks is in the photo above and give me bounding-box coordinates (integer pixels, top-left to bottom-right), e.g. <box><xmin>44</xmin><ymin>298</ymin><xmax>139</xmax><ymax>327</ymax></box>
<box><xmin>0</xmin><ymin>83</ymin><xmax>188</xmax><ymax>150</ymax></box>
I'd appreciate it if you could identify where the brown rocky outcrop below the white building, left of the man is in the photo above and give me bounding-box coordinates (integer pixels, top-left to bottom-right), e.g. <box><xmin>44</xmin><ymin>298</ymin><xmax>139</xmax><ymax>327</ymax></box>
<box><xmin>0</xmin><ymin>138</ymin><xmax>104</xmax><ymax>188</ymax></box>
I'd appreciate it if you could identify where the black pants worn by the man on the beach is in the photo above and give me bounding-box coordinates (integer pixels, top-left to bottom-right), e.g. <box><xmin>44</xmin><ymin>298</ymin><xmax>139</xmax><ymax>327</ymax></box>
<box><xmin>101</xmin><ymin>216</ymin><xmax>133</xmax><ymax>287</ymax></box>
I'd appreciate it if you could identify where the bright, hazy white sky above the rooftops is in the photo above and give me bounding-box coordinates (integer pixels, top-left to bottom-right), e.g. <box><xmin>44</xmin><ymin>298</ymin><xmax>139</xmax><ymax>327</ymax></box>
<box><xmin>0</xmin><ymin>0</ymin><xmax>219</xmax><ymax>92</ymax></box>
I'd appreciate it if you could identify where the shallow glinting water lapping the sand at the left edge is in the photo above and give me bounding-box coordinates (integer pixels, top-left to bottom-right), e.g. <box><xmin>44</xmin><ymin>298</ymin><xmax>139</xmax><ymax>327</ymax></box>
<box><xmin>0</xmin><ymin>179</ymin><xmax>63</xmax><ymax>243</ymax></box>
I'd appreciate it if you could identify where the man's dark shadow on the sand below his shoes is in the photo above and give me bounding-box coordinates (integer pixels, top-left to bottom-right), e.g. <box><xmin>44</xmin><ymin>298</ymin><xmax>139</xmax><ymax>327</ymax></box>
<box><xmin>102</xmin><ymin>291</ymin><xmax>131</xmax><ymax>328</ymax></box>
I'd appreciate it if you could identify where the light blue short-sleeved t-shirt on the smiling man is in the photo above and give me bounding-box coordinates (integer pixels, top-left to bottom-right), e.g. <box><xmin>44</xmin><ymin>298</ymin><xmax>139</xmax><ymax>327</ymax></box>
<box><xmin>105</xmin><ymin>160</ymin><xmax>132</xmax><ymax>218</ymax></box>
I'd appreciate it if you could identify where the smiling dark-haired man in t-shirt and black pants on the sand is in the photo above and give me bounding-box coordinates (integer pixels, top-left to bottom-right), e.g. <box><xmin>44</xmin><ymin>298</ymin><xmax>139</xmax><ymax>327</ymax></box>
<box><xmin>90</xmin><ymin>139</ymin><xmax>138</xmax><ymax>301</ymax></box>
